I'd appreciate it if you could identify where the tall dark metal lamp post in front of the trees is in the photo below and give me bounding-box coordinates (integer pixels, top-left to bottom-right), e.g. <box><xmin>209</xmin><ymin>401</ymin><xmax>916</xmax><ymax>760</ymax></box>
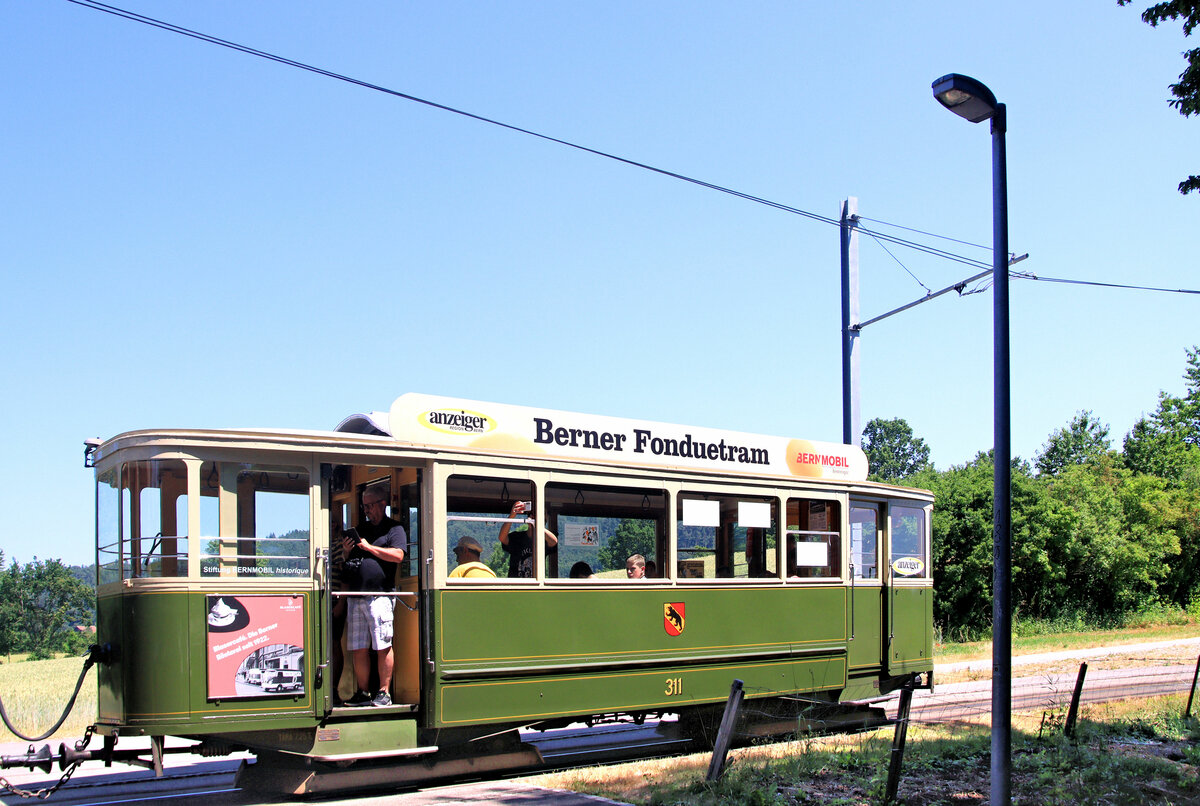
<box><xmin>932</xmin><ymin>73</ymin><xmax>1013</xmax><ymax>806</ymax></box>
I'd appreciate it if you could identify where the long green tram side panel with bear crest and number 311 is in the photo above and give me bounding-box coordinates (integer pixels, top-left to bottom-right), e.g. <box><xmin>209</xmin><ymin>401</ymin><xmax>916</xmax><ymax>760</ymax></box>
<box><xmin>436</xmin><ymin>585</ymin><xmax>847</xmax><ymax>727</ymax></box>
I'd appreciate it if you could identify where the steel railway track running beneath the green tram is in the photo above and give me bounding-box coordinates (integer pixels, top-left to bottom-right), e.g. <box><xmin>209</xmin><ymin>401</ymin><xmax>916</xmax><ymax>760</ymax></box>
<box><xmin>0</xmin><ymin>664</ymin><xmax>1195</xmax><ymax>806</ymax></box>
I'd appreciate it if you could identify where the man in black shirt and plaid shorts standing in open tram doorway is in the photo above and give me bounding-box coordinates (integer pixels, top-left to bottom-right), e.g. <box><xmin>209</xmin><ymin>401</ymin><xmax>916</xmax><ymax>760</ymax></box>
<box><xmin>342</xmin><ymin>487</ymin><xmax>408</xmax><ymax>706</ymax></box>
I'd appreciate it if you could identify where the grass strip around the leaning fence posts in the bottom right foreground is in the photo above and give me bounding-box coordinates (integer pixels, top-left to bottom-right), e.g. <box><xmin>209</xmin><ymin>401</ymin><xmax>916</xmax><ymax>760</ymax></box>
<box><xmin>530</xmin><ymin>697</ymin><xmax>1200</xmax><ymax>806</ymax></box>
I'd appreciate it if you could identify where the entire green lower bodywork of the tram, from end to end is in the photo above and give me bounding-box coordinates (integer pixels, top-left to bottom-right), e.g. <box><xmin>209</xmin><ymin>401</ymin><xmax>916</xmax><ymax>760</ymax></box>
<box><xmin>91</xmin><ymin>584</ymin><xmax>932</xmax><ymax>756</ymax></box>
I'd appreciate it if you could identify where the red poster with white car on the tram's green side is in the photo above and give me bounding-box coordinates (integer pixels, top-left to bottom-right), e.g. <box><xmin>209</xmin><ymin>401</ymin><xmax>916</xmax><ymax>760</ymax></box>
<box><xmin>205</xmin><ymin>594</ymin><xmax>305</xmax><ymax>699</ymax></box>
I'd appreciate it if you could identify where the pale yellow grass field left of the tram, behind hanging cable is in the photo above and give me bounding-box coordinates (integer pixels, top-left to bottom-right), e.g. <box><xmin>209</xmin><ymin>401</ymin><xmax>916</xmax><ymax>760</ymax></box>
<box><xmin>0</xmin><ymin>655</ymin><xmax>96</xmax><ymax>742</ymax></box>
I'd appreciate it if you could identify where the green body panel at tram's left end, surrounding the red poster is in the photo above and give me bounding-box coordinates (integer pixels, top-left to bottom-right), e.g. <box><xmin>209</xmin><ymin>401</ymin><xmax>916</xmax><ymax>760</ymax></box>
<box><xmin>97</xmin><ymin>590</ymin><xmax>317</xmax><ymax>735</ymax></box>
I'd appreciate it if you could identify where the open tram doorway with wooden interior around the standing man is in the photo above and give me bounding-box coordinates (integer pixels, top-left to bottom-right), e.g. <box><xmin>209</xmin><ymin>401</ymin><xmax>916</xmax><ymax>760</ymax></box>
<box><xmin>326</xmin><ymin>465</ymin><xmax>421</xmax><ymax>712</ymax></box>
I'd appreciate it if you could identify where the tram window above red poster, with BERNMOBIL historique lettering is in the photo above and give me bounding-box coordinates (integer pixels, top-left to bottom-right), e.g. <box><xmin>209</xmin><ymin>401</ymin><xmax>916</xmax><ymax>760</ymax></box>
<box><xmin>200</xmin><ymin>462</ymin><xmax>311</xmax><ymax>577</ymax></box>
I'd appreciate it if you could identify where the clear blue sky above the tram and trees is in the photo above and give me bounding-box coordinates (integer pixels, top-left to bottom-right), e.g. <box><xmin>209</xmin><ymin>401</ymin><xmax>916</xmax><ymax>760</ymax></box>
<box><xmin>0</xmin><ymin>0</ymin><xmax>1200</xmax><ymax>563</ymax></box>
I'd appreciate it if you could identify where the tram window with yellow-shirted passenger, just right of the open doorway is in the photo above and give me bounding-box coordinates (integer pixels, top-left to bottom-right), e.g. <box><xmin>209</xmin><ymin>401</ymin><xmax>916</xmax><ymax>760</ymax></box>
<box><xmin>445</xmin><ymin>476</ymin><xmax>540</xmax><ymax>583</ymax></box>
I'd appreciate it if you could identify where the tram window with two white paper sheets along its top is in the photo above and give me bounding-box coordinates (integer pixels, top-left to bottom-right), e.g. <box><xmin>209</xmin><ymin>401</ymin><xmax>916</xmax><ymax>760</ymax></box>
<box><xmin>676</xmin><ymin>493</ymin><xmax>779</xmax><ymax>579</ymax></box>
